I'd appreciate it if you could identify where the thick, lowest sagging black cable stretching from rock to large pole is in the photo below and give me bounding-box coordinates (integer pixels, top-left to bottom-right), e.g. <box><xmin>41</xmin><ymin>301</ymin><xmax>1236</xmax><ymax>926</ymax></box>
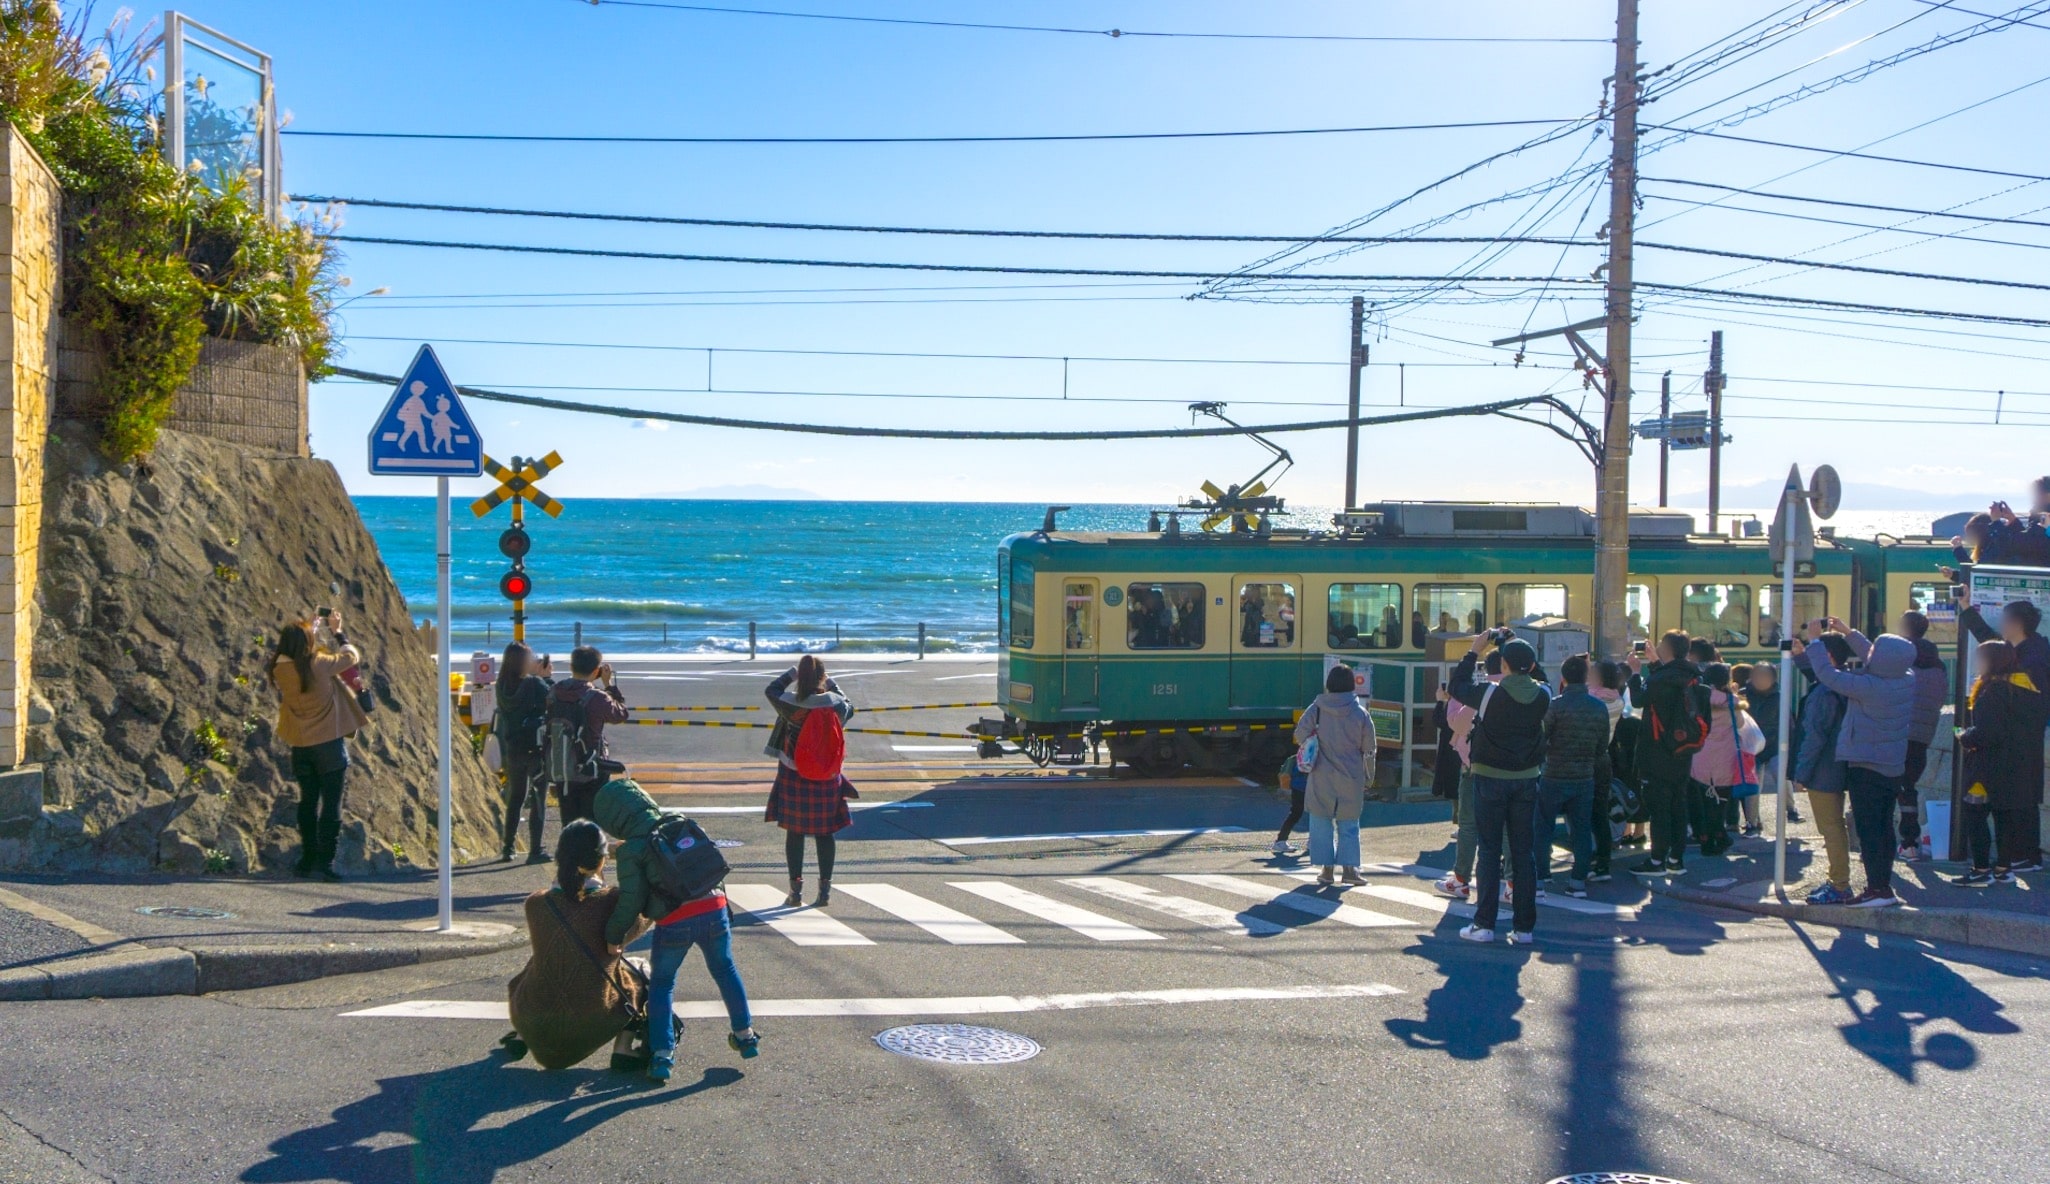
<box><xmin>334</xmin><ymin>367</ymin><xmax>1572</xmax><ymax>440</ymax></box>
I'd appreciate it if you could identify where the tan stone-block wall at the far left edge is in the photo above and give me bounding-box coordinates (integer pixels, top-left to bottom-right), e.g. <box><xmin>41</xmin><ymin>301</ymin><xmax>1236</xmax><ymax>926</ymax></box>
<box><xmin>0</xmin><ymin>125</ymin><xmax>64</xmax><ymax>766</ymax></box>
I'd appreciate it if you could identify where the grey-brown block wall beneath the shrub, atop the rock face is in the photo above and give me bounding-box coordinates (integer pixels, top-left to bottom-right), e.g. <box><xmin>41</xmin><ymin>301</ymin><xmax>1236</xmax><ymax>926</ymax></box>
<box><xmin>57</xmin><ymin>322</ymin><xmax>308</xmax><ymax>457</ymax></box>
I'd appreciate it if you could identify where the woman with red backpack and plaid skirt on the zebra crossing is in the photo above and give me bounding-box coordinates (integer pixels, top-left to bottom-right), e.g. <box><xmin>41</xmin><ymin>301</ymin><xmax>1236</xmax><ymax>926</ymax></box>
<box><xmin>763</xmin><ymin>653</ymin><xmax>861</xmax><ymax>910</ymax></box>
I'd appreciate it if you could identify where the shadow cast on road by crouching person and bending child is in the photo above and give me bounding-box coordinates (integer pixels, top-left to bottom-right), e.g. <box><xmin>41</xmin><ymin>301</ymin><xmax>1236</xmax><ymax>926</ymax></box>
<box><xmin>240</xmin><ymin>1040</ymin><xmax>742</xmax><ymax>1184</ymax></box>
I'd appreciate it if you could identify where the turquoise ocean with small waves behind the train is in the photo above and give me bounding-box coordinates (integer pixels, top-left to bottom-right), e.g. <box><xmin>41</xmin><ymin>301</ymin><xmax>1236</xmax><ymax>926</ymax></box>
<box><xmin>355</xmin><ymin>498</ymin><xmax>1931</xmax><ymax>653</ymax></box>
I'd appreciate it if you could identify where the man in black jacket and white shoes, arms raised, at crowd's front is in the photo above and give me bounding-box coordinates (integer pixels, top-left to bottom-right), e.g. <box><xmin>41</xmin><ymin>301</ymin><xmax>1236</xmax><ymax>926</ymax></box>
<box><xmin>1451</xmin><ymin>629</ymin><xmax>1552</xmax><ymax>944</ymax></box>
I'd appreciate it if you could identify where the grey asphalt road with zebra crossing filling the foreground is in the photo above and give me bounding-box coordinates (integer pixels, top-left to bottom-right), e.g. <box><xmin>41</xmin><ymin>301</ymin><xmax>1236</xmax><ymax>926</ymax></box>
<box><xmin>0</xmin><ymin>787</ymin><xmax>2050</xmax><ymax>1184</ymax></box>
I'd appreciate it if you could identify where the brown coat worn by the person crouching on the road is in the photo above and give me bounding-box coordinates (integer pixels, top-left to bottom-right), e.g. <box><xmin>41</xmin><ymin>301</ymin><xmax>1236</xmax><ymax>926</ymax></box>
<box><xmin>506</xmin><ymin>887</ymin><xmax>648</xmax><ymax>1069</ymax></box>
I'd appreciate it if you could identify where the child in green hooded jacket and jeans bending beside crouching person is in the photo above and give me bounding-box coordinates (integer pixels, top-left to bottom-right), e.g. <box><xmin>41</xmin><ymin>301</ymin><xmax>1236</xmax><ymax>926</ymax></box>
<box><xmin>590</xmin><ymin>776</ymin><xmax>761</xmax><ymax>1082</ymax></box>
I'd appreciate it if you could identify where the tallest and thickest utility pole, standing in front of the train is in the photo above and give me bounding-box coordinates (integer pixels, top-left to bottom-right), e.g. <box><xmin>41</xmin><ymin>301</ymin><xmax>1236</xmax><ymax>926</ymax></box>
<box><xmin>1595</xmin><ymin>0</ymin><xmax>1638</xmax><ymax>656</ymax></box>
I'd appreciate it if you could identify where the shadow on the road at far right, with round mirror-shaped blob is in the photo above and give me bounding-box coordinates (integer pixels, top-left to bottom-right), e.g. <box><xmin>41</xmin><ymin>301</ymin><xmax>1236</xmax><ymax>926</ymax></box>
<box><xmin>1788</xmin><ymin>924</ymin><xmax>2021</xmax><ymax>1082</ymax></box>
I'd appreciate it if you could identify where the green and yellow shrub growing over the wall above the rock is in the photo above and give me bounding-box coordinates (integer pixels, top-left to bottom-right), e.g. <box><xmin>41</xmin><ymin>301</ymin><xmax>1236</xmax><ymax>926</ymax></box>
<box><xmin>0</xmin><ymin>0</ymin><xmax>338</xmax><ymax>461</ymax></box>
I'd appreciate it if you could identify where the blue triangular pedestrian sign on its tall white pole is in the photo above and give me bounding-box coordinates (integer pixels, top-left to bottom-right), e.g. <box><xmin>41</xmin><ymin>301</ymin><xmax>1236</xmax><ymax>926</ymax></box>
<box><xmin>369</xmin><ymin>346</ymin><xmax>484</xmax><ymax>932</ymax></box>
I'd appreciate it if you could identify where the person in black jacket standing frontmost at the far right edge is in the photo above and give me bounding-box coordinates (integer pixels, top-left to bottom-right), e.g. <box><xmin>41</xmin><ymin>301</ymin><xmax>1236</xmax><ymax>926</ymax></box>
<box><xmin>1956</xmin><ymin>641</ymin><xmax>2050</xmax><ymax>887</ymax></box>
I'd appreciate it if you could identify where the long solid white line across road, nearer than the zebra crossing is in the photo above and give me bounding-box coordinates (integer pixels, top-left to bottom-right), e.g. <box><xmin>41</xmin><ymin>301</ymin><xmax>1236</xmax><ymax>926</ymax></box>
<box><xmin>342</xmin><ymin>983</ymin><xmax>1402</xmax><ymax>1022</ymax></box>
